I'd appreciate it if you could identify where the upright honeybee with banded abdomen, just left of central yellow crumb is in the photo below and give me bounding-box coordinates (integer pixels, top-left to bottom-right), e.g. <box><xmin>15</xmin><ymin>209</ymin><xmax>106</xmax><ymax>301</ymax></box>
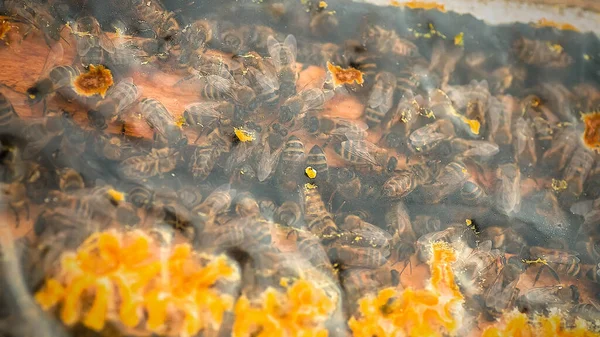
<box><xmin>278</xmin><ymin>136</ymin><xmax>306</xmax><ymax>190</ymax></box>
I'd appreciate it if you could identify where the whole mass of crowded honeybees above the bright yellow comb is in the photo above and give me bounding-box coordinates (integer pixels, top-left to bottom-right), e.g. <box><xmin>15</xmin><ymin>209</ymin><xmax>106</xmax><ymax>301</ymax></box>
<box><xmin>0</xmin><ymin>0</ymin><xmax>600</xmax><ymax>335</ymax></box>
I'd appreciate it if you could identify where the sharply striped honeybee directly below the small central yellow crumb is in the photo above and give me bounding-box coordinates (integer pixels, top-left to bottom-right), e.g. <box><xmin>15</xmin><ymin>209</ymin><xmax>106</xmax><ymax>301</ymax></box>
<box><xmin>302</xmin><ymin>184</ymin><xmax>338</xmax><ymax>242</ymax></box>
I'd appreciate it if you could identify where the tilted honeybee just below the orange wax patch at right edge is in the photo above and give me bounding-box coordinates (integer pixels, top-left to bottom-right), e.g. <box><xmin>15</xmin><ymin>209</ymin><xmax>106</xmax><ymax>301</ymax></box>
<box><xmin>560</xmin><ymin>146</ymin><xmax>596</xmax><ymax>200</ymax></box>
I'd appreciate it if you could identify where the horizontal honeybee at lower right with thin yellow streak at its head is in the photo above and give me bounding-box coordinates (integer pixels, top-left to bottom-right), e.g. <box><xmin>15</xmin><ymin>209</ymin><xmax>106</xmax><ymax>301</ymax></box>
<box><xmin>526</xmin><ymin>246</ymin><xmax>581</xmax><ymax>285</ymax></box>
